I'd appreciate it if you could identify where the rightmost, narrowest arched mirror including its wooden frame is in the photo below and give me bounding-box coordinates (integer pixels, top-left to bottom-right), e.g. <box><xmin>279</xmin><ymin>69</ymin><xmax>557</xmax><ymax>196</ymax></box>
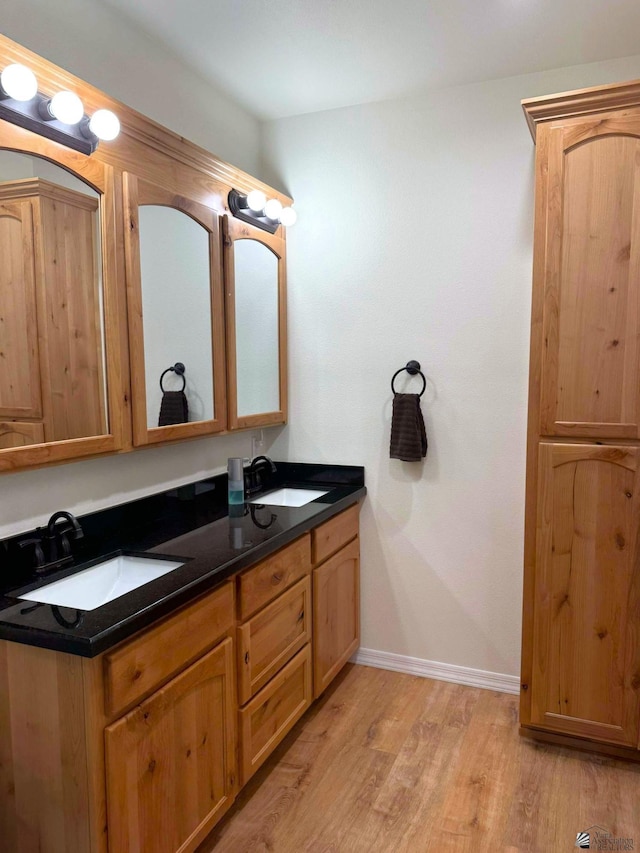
<box><xmin>224</xmin><ymin>218</ymin><xmax>287</xmax><ymax>429</ymax></box>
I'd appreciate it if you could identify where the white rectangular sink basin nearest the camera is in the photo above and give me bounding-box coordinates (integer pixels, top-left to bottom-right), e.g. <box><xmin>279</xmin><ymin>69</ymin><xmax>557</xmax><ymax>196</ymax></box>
<box><xmin>18</xmin><ymin>554</ymin><xmax>184</xmax><ymax>610</ymax></box>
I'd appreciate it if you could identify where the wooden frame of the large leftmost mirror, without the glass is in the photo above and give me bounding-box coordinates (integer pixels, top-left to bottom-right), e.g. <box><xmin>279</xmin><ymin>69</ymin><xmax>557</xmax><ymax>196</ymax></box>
<box><xmin>0</xmin><ymin>120</ymin><xmax>128</xmax><ymax>472</ymax></box>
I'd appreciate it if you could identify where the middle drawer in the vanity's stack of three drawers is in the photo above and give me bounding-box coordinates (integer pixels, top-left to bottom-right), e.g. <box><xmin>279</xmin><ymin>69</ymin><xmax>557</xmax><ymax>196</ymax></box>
<box><xmin>238</xmin><ymin>577</ymin><xmax>311</xmax><ymax>705</ymax></box>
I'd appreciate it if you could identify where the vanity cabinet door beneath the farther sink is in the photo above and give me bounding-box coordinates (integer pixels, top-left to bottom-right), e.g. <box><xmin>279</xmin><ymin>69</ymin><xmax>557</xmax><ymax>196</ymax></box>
<box><xmin>313</xmin><ymin>539</ymin><xmax>360</xmax><ymax>698</ymax></box>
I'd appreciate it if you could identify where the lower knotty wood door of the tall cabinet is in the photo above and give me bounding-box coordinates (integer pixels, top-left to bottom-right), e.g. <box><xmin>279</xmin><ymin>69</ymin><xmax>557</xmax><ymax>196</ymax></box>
<box><xmin>531</xmin><ymin>444</ymin><xmax>640</xmax><ymax>746</ymax></box>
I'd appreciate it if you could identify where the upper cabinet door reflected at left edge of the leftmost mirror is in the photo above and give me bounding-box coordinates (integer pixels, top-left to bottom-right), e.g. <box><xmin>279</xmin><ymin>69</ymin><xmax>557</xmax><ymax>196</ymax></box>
<box><xmin>0</xmin><ymin>200</ymin><xmax>42</xmax><ymax>426</ymax></box>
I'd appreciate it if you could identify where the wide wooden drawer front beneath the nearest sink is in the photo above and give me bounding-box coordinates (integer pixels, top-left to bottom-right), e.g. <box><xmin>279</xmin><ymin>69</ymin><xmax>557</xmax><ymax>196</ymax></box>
<box><xmin>104</xmin><ymin>582</ymin><xmax>233</xmax><ymax>715</ymax></box>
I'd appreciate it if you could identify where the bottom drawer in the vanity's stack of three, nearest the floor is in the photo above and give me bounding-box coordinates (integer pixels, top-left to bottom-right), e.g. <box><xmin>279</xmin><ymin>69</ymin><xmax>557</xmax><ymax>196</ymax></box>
<box><xmin>240</xmin><ymin>645</ymin><xmax>313</xmax><ymax>784</ymax></box>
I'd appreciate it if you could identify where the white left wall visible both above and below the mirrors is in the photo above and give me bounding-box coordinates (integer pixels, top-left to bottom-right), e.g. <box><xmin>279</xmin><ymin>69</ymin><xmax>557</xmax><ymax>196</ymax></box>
<box><xmin>0</xmin><ymin>6</ymin><xmax>277</xmax><ymax>538</ymax></box>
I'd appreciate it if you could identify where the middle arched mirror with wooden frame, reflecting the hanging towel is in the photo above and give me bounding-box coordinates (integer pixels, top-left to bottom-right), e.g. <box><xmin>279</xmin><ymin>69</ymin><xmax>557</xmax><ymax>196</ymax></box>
<box><xmin>125</xmin><ymin>174</ymin><xmax>226</xmax><ymax>445</ymax></box>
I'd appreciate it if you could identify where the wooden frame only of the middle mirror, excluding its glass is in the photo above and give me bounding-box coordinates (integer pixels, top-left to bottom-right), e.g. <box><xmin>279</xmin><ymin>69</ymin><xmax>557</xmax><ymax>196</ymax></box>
<box><xmin>124</xmin><ymin>172</ymin><xmax>227</xmax><ymax>446</ymax></box>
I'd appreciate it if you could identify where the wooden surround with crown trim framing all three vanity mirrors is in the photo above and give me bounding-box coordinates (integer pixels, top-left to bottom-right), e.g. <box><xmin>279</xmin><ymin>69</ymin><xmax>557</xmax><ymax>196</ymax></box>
<box><xmin>0</xmin><ymin>34</ymin><xmax>292</xmax><ymax>474</ymax></box>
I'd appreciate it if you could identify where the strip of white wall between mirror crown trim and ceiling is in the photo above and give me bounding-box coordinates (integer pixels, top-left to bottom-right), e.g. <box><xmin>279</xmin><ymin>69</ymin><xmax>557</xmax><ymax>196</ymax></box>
<box><xmin>0</xmin><ymin>0</ymin><xmax>259</xmax><ymax>174</ymax></box>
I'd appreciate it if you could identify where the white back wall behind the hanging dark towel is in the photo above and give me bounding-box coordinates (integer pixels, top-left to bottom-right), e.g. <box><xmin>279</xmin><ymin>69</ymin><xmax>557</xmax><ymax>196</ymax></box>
<box><xmin>264</xmin><ymin>57</ymin><xmax>640</xmax><ymax>674</ymax></box>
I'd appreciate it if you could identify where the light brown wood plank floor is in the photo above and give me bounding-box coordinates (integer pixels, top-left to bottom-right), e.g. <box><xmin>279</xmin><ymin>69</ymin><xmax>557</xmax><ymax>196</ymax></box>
<box><xmin>198</xmin><ymin>664</ymin><xmax>640</xmax><ymax>853</ymax></box>
